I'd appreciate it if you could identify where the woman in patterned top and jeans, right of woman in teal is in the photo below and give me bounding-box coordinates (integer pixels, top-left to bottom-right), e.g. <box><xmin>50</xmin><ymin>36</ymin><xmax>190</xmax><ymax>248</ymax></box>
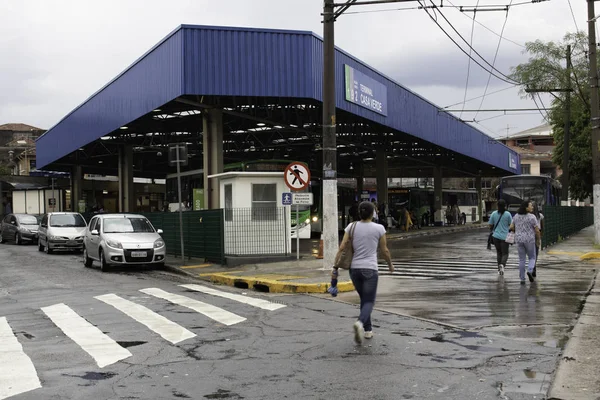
<box><xmin>510</xmin><ymin>201</ymin><xmax>540</xmax><ymax>284</ymax></box>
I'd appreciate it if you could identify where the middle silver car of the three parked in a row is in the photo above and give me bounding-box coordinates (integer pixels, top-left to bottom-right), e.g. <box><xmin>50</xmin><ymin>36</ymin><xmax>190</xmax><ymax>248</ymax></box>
<box><xmin>38</xmin><ymin>212</ymin><xmax>86</xmax><ymax>254</ymax></box>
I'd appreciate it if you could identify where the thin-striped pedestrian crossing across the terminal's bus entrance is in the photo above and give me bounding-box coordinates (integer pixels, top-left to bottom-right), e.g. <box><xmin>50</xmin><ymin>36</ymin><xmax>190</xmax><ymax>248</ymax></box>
<box><xmin>379</xmin><ymin>258</ymin><xmax>519</xmax><ymax>280</ymax></box>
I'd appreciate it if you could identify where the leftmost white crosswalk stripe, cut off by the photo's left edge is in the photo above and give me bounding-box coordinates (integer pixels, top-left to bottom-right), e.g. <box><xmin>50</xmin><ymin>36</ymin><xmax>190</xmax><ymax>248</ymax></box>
<box><xmin>0</xmin><ymin>317</ymin><xmax>42</xmax><ymax>399</ymax></box>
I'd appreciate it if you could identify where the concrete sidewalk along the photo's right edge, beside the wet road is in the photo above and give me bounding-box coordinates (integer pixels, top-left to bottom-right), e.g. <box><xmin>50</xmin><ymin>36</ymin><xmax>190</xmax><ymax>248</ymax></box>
<box><xmin>546</xmin><ymin>227</ymin><xmax>600</xmax><ymax>400</ymax></box>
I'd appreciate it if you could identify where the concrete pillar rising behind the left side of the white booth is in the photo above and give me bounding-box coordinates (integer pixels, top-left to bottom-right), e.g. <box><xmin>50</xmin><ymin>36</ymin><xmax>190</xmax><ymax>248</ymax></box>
<box><xmin>202</xmin><ymin>109</ymin><xmax>223</xmax><ymax>210</ymax></box>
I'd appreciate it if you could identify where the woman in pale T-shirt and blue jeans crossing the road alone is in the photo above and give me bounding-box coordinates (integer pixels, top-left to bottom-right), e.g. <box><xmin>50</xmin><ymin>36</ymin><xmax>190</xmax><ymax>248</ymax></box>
<box><xmin>332</xmin><ymin>202</ymin><xmax>394</xmax><ymax>344</ymax></box>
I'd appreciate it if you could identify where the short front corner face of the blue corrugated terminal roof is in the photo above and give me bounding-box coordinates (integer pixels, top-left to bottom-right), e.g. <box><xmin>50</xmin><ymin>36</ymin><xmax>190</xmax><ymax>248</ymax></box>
<box><xmin>184</xmin><ymin>27</ymin><xmax>312</xmax><ymax>98</ymax></box>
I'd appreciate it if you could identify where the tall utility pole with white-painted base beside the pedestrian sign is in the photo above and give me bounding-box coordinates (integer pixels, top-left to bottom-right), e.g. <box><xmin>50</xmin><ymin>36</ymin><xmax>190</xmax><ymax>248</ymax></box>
<box><xmin>322</xmin><ymin>0</ymin><xmax>339</xmax><ymax>268</ymax></box>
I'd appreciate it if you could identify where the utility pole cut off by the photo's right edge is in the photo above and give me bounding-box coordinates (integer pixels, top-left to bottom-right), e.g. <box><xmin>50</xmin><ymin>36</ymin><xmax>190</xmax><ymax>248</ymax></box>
<box><xmin>587</xmin><ymin>0</ymin><xmax>600</xmax><ymax>244</ymax></box>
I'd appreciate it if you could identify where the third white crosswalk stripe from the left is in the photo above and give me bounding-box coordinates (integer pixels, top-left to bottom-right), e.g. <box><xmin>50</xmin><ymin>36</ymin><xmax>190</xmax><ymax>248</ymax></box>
<box><xmin>96</xmin><ymin>293</ymin><xmax>196</xmax><ymax>344</ymax></box>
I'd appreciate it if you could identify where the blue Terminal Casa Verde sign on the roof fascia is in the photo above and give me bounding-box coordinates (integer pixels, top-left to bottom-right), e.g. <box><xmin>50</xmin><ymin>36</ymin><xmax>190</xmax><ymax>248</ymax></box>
<box><xmin>345</xmin><ymin>65</ymin><xmax>387</xmax><ymax>116</ymax></box>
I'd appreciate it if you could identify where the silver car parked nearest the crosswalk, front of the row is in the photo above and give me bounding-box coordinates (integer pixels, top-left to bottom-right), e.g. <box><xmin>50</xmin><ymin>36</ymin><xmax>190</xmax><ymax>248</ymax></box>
<box><xmin>83</xmin><ymin>214</ymin><xmax>166</xmax><ymax>271</ymax></box>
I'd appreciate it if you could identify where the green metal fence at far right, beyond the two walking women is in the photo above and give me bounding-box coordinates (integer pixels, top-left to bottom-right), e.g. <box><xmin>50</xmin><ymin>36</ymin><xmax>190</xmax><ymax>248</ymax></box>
<box><xmin>542</xmin><ymin>206</ymin><xmax>594</xmax><ymax>248</ymax></box>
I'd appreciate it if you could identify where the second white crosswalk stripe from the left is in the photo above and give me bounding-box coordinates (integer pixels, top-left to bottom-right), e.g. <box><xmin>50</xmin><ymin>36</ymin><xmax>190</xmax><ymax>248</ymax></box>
<box><xmin>42</xmin><ymin>303</ymin><xmax>132</xmax><ymax>368</ymax></box>
